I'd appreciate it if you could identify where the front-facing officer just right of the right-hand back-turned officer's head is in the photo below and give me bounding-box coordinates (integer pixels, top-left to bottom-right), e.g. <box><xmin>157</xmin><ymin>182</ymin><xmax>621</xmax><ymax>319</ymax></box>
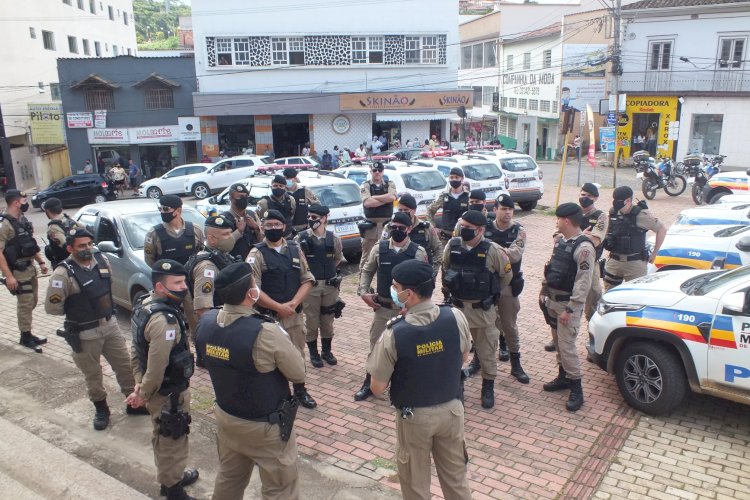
<box><xmin>443</xmin><ymin>210</ymin><xmax>513</xmax><ymax>408</ymax></box>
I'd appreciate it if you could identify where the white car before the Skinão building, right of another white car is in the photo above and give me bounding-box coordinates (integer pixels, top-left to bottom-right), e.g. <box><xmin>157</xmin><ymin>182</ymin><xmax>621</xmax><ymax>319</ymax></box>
<box><xmin>183</xmin><ymin>155</ymin><xmax>269</xmax><ymax>200</ymax></box>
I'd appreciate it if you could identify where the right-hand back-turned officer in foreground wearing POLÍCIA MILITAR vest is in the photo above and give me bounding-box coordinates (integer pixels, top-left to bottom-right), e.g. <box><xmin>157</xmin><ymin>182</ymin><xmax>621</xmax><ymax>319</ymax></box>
<box><xmin>367</xmin><ymin>260</ymin><xmax>471</xmax><ymax>500</ymax></box>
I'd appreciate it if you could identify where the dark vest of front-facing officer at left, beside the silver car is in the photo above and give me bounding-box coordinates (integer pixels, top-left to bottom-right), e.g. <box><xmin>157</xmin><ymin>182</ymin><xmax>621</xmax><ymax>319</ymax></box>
<box><xmin>60</xmin><ymin>253</ymin><xmax>114</xmax><ymax>330</ymax></box>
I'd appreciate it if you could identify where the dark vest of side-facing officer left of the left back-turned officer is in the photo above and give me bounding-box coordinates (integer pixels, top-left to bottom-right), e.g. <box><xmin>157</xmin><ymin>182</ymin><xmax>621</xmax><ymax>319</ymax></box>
<box><xmin>130</xmin><ymin>295</ymin><xmax>195</xmax><ymax>396</ymax></box>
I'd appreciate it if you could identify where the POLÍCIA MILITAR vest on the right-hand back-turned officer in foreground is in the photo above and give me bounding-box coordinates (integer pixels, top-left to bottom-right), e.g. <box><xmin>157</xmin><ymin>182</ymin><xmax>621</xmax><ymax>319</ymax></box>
<box><xmin>391</xmin><ymin>306</ymin><xmax>463</xmax><ymax>408</ymax></box>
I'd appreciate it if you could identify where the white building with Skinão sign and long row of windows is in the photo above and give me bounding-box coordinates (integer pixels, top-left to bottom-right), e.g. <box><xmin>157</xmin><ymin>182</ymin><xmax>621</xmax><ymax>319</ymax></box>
<box><xmin>192</xmin><ymin>0</ymin><xmax>471</xmax><ymax>157</ymax></box>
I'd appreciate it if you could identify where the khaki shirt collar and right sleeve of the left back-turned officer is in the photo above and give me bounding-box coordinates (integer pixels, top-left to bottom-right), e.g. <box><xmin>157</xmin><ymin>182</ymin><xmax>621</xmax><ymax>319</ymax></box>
<box><xmin>216</xmin><ymin>304</ymin><xmax>305</xmax><ymax>384</ymax></box>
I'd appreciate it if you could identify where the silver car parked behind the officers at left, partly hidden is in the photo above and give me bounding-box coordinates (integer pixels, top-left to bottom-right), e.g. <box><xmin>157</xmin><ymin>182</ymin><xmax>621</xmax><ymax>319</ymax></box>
<box><xmin>73</xmin><ymin>200</ymin><xmax>206</xmax><ymax>310</ymax></box>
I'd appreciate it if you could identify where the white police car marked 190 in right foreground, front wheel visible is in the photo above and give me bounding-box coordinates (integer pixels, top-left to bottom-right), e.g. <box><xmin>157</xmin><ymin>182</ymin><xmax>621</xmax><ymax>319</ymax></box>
<box><xmin>587</xmin><ymin>266</ymin><xmax>750</xmax><ymax>415</ymax></box>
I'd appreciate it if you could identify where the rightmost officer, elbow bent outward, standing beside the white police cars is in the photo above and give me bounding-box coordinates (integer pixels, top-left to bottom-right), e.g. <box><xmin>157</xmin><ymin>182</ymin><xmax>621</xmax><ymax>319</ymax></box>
<box><xmin>604</xmin><ymin>186</ymin><xmax>667</xmax><ymax>291</ymax></box>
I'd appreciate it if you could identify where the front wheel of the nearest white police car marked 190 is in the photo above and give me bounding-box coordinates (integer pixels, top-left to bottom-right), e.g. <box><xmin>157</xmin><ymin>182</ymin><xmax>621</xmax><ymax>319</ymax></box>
<box><xmin>615</xmin><ymin>342</ymin><xmax>688</xmax><ymax>415</ymax></box>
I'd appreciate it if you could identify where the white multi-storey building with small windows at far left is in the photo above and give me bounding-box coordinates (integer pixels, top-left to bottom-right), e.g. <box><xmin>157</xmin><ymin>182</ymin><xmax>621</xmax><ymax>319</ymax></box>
<box><xmin>0</xmin><ymin>0</ymin><xmax>136</xmax><ymax>189</ymax></box>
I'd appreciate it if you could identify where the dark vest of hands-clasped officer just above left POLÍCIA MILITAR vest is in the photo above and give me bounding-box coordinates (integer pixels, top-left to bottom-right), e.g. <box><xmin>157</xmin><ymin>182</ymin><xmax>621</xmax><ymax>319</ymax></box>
<box><xmin>255</xmin><ymin>241</ymin><xmax>302</xmax><ymax>304</ymax></box>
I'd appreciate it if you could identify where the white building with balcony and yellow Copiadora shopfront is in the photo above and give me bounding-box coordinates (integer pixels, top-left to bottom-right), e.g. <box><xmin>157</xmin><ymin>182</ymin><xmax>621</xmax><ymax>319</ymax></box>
<box><xmin>620</xmin><ymin>0</ymin><xmax>750</xmax><ymax>166</ymax></box>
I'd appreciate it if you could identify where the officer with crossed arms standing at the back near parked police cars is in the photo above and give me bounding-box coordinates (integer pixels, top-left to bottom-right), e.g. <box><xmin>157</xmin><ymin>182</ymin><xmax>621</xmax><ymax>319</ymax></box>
<box><xmin>359</xmin><ymin>161</ymin><xmax>397</xmax><ymax>269</ymax></box>
